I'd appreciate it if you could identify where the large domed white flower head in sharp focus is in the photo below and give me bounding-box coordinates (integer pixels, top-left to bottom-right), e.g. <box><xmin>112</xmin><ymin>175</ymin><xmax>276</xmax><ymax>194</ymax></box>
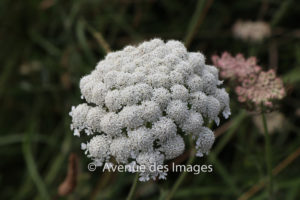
<box><xmin>70</xmin><ymin>39</ymin><xmax>230</xmax><ymax>181</ymax></box>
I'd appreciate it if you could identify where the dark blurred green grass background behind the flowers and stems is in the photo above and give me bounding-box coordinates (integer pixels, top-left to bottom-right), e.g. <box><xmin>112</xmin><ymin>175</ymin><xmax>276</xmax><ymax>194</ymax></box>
<box><xmin>0</xmin><ymin>0</ymin><xmax>300</xmax><ymax>200</ymax></box>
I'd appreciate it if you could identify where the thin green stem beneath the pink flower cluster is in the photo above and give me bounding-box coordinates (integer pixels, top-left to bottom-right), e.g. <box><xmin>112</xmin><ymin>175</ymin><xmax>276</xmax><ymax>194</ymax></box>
<box><xmin>261</xmin><ymin>105</ymin><xmax>273</xmax><ymax>199</ymax></box>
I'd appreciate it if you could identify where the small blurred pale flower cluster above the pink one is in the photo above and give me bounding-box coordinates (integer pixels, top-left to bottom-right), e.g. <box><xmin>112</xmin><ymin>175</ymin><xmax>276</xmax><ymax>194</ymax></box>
<box><xmin>233</xmin><ymin>21</ymin><xmax>271</xmax><ymax>42</ymax></box>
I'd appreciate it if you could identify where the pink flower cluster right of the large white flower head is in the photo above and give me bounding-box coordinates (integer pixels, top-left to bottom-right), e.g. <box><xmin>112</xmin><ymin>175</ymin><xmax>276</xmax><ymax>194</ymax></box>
<box><xmin>212</xmin><ymin>52</ymin><xmax>285</xmax><ymax>107</ymax></box>
